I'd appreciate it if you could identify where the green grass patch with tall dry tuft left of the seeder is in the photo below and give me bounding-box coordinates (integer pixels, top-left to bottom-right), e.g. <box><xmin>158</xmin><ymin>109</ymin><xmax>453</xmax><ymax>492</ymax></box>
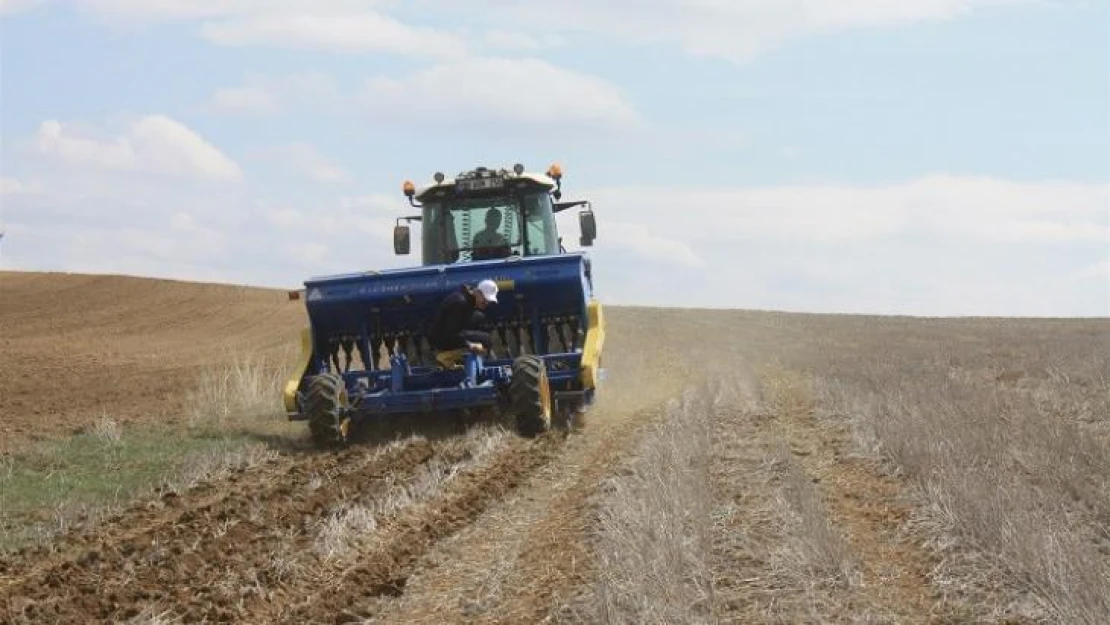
<box><xmin>0</xmin><ymin>356</ymin><xmax>303</xmax><ymax>553</ymax></box>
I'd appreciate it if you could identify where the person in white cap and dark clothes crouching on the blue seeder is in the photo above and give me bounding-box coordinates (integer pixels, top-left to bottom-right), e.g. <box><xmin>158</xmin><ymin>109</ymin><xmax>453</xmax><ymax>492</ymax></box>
<box><xmin>427</xmin><ymin>280</ymin><xmax>497</xmax><ymax>354</ymax></box>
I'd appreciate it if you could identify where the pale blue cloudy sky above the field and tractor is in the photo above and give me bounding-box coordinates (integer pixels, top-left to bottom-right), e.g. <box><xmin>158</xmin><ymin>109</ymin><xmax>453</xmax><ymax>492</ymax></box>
<box><xmin>0</xmin><ymin>0</ymin><xmax>1110</xmax><ymax>316</ymax></box>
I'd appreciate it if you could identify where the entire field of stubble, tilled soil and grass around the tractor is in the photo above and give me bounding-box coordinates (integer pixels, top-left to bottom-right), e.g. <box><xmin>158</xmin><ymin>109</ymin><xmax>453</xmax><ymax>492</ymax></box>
<box><xmin>0</xmin><ymin>273</ymin><xmax>1110</xmax><ymax>624</ymax></box>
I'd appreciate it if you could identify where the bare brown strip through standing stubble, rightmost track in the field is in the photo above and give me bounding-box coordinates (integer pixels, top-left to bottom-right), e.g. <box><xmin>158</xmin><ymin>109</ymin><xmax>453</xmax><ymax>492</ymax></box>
<box><xmin>718</xmin><ymin>372</ymin><xmax>937</xmax><ymax>623</ymax></box>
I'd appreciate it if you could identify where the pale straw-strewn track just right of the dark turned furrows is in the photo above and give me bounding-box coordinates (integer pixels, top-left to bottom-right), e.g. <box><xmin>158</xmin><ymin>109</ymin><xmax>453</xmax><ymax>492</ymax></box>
<box><xmin>359</xmin><ymin>410</ymin><xmax>657</xmax><ymax>624</ymax></box>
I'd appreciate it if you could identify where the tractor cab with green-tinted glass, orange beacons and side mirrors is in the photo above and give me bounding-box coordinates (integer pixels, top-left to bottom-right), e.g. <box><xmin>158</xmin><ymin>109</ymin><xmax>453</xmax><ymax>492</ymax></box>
<box><xmin>393</xmin><ymin>164</ymin><xmax>596</xmax><ymax>265</ymax></box>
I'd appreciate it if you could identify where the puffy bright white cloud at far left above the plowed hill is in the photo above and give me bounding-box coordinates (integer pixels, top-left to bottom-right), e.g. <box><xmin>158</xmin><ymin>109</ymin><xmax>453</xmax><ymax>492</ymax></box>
<box><xmin>36</xmin><ymin>115</ymin><xmax>242</xmax><ymax>181</ymax></box>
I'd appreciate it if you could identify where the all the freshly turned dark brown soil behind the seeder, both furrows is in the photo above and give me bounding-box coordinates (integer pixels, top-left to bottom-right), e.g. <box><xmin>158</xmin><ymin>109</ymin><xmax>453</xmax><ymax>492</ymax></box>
<box><xmin>0</xmin><ymin>434</ymin><xmax>561</xmax><ymax>625</ymax></box>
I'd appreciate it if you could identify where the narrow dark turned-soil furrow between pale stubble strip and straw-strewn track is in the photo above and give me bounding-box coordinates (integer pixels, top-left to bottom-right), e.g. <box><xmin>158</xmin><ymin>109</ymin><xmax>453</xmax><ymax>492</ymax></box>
<box><xmin>263</xmin><ymin>433</ymin><xmax>563</xmax><ymax>623</ymax></box>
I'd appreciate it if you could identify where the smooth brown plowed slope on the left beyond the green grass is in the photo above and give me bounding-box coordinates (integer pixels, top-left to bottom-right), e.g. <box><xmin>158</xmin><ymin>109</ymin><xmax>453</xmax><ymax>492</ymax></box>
<box><xmin>0</xmin><ymin>272</ymin><xmax>304</xmax><ymax>454</ymax></box>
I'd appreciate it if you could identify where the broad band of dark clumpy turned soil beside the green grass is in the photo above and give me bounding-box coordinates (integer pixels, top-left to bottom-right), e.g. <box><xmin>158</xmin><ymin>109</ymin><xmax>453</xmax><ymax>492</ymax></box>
<box><xmin>0</xmin><ymin>440</ymin><xmax>450</xmax><ymax>623</ymax></box>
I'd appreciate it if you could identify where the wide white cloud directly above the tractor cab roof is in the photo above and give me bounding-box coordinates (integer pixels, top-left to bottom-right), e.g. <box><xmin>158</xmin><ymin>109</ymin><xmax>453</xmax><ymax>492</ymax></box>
<box><xmin>361</xmin><ymin>58</ymin><xmax>640</xmax><ymax>128</ymax></box>
